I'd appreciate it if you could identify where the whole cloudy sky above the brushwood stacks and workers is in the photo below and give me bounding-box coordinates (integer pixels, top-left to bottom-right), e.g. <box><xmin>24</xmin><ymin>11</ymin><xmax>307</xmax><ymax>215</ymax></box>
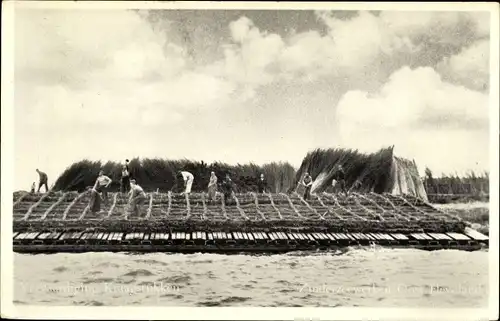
<box><xmin>14</xmin><ymin>9</ymin><xmax>490</xmax><ymax>189</ymax></box>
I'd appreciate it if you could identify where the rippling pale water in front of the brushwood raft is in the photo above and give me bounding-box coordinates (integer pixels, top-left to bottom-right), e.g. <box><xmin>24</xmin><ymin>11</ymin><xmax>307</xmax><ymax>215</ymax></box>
<box><xmin>14</xmin><ymin>247</ymin><xmax>489</xmax><ymax>308</ymax></box>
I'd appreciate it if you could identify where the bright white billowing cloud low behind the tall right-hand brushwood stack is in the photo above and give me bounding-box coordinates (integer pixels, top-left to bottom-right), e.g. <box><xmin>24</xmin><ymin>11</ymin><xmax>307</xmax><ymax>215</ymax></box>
<box><xmin>337</xmin><ymin>67</ymin><xmax>489</xmax><ymax>173</ymax></box>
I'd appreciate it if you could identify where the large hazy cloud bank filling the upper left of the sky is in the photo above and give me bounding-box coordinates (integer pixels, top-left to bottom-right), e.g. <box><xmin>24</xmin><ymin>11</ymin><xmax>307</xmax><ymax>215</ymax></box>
<box><xmin>15</xmin><ymin>10</ymin><xmax>242</xmax><ymax>126</ymax></box>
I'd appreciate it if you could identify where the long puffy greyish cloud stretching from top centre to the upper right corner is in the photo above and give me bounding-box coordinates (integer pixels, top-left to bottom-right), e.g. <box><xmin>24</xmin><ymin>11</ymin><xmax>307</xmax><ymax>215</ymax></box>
<box><xmin>218</xmin><ymin>11</ymin><xmax>489</xmax><ymax>88</ymax></box>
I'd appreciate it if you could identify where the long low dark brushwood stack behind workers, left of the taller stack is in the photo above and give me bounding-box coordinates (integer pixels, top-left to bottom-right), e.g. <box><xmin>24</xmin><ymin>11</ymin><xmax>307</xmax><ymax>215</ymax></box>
<box><xmin>54</xmin><ymin>158</ymin><xmax>295</xmax><ymax>192</ymax></box>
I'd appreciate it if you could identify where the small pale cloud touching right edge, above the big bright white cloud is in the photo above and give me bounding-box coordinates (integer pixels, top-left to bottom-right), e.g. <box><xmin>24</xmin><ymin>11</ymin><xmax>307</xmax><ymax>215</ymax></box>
<box><xmin>438</xmin><ymin>40</ymin><xmax>490</xmax><ymax>90</ymax></box>
